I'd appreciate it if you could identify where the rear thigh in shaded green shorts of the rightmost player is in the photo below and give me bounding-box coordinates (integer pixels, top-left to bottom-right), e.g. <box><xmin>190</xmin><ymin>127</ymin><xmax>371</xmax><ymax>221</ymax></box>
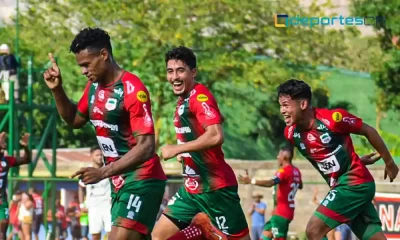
<box><xmin>349</xmin><ymin>202</ymin><xmax>382</xmax><ymax>240</ymax></box>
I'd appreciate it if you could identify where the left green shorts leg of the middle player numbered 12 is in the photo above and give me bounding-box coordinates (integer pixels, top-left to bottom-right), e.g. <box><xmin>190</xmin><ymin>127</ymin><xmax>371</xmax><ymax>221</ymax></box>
<box><xmin>163</xmin><ymin>187</ymin><xmax>201</xmax><ymax>230</ymax></box>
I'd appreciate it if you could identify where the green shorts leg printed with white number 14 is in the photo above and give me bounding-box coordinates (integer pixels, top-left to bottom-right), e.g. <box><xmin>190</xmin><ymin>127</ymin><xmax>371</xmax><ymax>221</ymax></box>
<box><xmin>111</xmin><ymin>181</ymin><xmax>165</xmax><ymax>236</ymax></box>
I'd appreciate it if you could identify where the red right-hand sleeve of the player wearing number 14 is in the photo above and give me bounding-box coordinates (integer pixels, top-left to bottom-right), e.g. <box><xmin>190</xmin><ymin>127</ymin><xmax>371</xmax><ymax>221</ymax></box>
<box><xmin>124</xmin><ymin>79</ymin><xmax>154</xmax><ymax>137</ymax></box>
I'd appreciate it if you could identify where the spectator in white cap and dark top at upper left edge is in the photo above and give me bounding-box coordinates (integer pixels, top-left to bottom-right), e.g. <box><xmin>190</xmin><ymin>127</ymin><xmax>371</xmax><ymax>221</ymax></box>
<box><xmin>0</xmin><ymin>44</ymin><xmax>19</xmax><ymax>102</ymax></box>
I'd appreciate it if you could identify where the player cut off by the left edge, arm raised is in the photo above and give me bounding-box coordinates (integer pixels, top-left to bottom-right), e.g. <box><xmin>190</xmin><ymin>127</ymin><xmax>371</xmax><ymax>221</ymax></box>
<box><xmin>0</xmin><ymin>132</ymin><xmax>32</xmax><ymax>240</ymax></box>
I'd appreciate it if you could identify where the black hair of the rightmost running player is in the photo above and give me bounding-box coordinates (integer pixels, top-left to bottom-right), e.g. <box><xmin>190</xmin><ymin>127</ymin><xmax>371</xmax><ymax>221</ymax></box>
<box><xmin>277</xmin><ymin>79</ymin><xmax>312</xmax><ymax>102</ymax></box>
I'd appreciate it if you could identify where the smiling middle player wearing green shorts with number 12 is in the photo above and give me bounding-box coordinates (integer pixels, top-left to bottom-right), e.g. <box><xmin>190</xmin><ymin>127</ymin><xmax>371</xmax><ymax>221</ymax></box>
<box><xmin>152</xmin><ymin>47</ymin><xmax>250</xmax><ymax>240</ymax></box>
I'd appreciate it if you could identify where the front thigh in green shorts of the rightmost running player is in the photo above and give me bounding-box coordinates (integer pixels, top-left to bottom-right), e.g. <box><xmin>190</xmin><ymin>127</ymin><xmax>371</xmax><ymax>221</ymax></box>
<box><xmin>314</xmin><ymin>183</ymin><xmax>375</xmax><ymax>229</ymax></box>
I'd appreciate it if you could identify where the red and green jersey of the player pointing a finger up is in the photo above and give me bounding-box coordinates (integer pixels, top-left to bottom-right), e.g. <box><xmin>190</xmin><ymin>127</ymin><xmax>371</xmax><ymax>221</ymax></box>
<box><xmin>78</xmin><ymin>72</ymin><xmax>166</xmax><ymax>191</ymax></box>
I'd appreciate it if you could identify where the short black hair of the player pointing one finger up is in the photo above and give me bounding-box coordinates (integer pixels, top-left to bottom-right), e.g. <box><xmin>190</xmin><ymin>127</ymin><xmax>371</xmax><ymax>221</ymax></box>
<box><xmin>69</xmin><ymin>27</ymin><xmax>112</xmax><ymax>55</ymax></box>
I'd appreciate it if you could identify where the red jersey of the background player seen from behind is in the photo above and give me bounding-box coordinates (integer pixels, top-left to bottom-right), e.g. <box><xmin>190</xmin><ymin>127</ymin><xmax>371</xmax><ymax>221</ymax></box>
<box><xmin>272</xmin><ymin>164</ymin><xmax>302</xmax><ymax>220</ymax></box>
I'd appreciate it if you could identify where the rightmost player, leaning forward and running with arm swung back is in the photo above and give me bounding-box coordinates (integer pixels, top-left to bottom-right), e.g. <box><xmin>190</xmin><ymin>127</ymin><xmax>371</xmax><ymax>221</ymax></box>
<box><xmin>277</xmin><ymin>79</ymin><xmax>399</xmax><ymax>240</ymax></box>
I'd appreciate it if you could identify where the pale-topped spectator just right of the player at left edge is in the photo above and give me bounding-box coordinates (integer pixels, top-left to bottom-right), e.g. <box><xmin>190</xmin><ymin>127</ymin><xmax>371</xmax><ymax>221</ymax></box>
<box><xmin>18</xmin><ymin>192</ymin><xmax>34</xmax><ymax>240</ymax></box>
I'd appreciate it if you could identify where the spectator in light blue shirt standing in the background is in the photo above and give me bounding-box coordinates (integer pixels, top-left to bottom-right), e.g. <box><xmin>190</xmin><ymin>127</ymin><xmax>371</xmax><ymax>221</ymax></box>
<box><xmin>249</xmin><ymin>193</ymin><xmax>267</xmax><ymax>240</ymax></box>
